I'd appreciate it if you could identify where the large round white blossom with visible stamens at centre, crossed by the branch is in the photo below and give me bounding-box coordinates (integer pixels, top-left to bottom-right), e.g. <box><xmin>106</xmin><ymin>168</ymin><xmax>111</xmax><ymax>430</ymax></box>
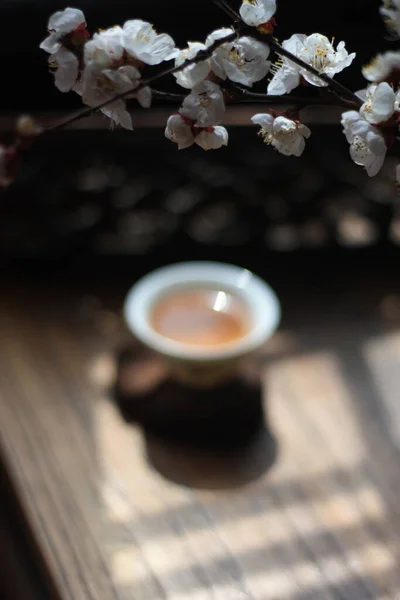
<box><xmin>206</xmin><ymin>29</ymin><xmax>271</xmax><ymax>86</ymax></box>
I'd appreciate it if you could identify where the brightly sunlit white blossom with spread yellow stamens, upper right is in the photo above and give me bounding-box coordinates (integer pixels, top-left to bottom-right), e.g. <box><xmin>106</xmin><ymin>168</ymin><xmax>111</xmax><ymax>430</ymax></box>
<box><xmin>268</xmin><ymin>33</ymin><xmax>355</xmax><ymax>95</ymax></box>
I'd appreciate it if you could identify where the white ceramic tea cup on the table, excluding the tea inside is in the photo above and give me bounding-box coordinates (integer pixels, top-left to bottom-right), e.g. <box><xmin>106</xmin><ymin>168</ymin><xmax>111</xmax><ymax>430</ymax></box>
<box><xmin>124</xmin><ymin>262</ymin><xmax>281</xmax><ymax>386</ymax></box>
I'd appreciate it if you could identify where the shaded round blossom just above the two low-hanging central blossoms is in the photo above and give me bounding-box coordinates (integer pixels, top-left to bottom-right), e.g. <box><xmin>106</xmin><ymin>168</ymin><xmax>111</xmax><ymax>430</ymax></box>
<box><xmin>179</xmin><ymin>80</ymin><xmax>225</xmax><ymax>127</ymax></box>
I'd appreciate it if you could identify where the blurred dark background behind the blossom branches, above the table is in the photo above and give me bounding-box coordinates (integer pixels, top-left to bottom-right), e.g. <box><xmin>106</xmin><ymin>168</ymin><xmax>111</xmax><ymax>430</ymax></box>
<box><xmin>0</xmin><ymin>0</ymin><xmax>400</xmax><ymax>270</ymax></box>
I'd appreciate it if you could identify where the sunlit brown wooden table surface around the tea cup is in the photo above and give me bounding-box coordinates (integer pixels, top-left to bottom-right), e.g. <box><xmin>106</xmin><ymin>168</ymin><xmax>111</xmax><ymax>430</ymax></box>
<box><xmin>0</xmin><ymin>274</ymin><xmax>400</xmax><ymax>600</ymax></box>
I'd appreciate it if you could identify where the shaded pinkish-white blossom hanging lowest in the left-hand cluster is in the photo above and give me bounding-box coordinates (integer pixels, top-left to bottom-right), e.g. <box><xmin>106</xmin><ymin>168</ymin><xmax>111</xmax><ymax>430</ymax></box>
<box><xmin>78</xmin><ymin>65</ymin><xmax>151</xmax><ymax>129</ymax></box>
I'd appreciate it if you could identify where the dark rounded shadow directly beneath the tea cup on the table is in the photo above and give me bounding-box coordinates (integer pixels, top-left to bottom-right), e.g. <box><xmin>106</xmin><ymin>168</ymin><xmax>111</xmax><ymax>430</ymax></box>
<box><xmin>114</xmin><ymin>345</ymin><xmax>277</xmax><ymax>489</ymax></box>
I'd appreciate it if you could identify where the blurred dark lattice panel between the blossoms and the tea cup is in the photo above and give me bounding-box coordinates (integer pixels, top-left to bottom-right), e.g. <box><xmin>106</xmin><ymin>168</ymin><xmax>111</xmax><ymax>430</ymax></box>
<box><xmin>0</xmin><ymin>126</ymin><xmax>400</xmax><ymax>258</ymax></box>
